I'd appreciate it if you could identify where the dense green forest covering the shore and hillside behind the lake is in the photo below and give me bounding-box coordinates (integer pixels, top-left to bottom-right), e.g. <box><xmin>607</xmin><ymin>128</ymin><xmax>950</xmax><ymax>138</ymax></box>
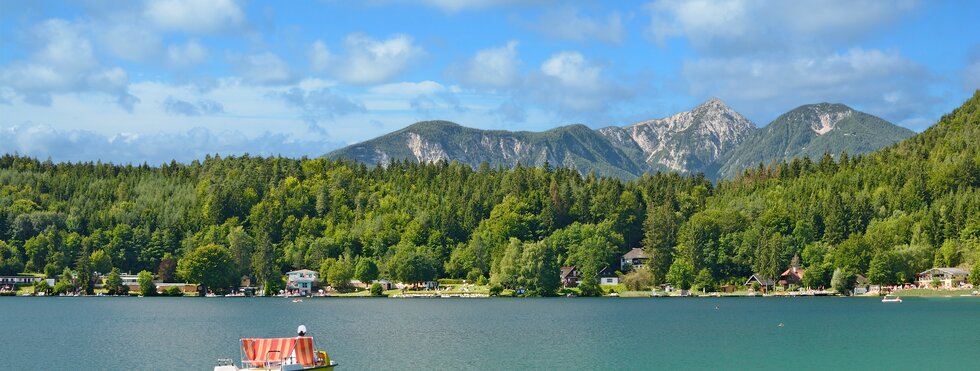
<box><xmin>0</xmin><ymin>92</ymin><xmax>980</xmax><ymax>295</ymax></box>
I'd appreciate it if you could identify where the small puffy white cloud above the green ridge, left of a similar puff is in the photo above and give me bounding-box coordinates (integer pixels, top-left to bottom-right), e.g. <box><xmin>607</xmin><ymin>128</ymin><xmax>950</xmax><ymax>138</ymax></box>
<box><xmin>448</xmin><ymin>41</ymin><xmax>521</xmax><ymax>88</ymax></box>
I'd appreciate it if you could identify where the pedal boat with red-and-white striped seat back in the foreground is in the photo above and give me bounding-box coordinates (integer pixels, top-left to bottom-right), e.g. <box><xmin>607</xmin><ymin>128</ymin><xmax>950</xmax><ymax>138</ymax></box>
<box><xmin>214</xmin><ymin>326</ymin><xmax>337</xmax><ymax>371</ymax></box>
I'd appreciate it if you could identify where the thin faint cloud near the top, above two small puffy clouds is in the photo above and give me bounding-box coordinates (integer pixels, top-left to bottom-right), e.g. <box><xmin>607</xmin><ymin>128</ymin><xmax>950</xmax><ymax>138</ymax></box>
<box><xmin>531</xmin><ymin>8</ymin><xmax>626</xmax><ymax>44</ymax></box>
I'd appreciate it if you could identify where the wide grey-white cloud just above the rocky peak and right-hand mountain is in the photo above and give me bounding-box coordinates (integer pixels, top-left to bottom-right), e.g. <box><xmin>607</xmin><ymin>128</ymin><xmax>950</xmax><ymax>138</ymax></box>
<box><xmin>681</xmin><ymin>49</ymin><xmax>935</xmax><ymax>121</ymax></box>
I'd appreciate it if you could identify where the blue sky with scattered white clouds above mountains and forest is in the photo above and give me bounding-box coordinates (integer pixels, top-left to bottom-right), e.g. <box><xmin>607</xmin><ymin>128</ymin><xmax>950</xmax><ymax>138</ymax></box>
<box><xmin>0</xmin><ymin>0</ymin><xmax>980</xmax><ymax>164</ymax></box>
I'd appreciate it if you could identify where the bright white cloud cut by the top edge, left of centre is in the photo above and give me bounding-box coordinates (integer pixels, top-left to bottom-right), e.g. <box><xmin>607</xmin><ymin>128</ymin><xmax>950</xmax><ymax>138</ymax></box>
<box><xmin>143</xmin><ymin>0</ymin><xmax>245</xmax><ymax>33</ymax></box>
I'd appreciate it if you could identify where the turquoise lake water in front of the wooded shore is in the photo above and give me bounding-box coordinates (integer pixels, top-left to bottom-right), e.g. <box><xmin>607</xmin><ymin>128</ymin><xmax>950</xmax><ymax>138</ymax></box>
<box><xmin>0</xmin><ymin>297</ymin><xmax>980</xmax><ymax>370</ymax></box>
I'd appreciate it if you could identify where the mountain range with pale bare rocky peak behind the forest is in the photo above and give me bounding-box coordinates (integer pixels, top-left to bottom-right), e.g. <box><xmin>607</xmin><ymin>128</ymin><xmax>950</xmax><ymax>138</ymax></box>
<box><xmin>326</xmin><ymin>98</ymin><xmax>914</xmax><ymax>179</ymax></box>
